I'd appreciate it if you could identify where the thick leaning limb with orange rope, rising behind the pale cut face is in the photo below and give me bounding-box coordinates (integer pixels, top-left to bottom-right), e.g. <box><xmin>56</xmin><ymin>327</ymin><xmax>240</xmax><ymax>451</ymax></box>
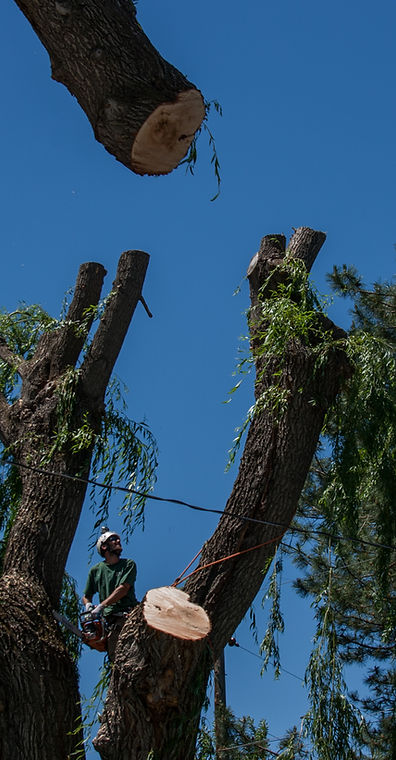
<box><xmin>185</xmin><ymin>227</ymin><xmax>347</xmax><ymax>655</ymax></box>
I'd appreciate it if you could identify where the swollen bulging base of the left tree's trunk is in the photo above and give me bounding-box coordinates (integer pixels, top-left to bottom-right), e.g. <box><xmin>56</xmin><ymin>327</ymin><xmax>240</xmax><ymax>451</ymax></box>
<box><xmin>0</xmin><ymin>571</ymin><xmax>83</xmax><ymax>760</ymax></box>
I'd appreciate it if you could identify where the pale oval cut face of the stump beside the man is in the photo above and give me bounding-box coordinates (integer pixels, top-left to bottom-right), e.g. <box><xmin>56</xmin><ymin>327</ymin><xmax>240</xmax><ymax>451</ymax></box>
<box><xmin>143</xmin><ymin>586</ymin><xmax>211</xmax><ymax>641</ymax></box>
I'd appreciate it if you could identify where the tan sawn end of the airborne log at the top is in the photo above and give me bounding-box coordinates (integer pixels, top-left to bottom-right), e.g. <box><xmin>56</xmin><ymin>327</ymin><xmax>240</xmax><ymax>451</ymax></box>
<box><xmin>131</xmin><ymin>89</ymin><xmax>205</xmax><ymax>174</ymax></box>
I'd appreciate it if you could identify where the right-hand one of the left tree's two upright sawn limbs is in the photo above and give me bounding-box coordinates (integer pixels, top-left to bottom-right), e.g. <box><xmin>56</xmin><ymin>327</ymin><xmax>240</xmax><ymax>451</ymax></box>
<box><xmin>82</xmin><ymin>251</ymin><xmax>150</xmax><ymax>401</ymax></box>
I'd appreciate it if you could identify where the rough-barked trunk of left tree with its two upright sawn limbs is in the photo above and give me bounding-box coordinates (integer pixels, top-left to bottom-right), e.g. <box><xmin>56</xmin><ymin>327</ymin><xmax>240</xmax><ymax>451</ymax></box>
<box><xmin>0</xmin><ymin>251</ymin><xmax>148</xmax><ymax>760</ymax></box>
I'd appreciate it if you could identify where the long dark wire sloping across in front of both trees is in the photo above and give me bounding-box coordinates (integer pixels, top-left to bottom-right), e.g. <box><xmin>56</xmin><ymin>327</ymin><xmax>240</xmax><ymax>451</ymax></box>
<box><xmin>3</xmin><ymin>459</ymin><xmax>396</xmax><ymax>551</ymax></box>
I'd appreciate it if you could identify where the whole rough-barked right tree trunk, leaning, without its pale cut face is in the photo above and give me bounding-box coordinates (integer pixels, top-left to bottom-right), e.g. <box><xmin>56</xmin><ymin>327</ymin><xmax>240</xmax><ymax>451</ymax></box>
<box><xmin>95</xmin><ymin>228</ymin><xmax>350</xmax><ymax>760</ymax></box>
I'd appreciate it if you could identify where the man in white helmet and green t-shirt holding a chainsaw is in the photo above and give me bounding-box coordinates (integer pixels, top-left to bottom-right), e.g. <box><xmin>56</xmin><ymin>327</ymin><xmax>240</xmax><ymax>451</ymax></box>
<box><xmin>82</xmin><ymin>526</ymin><xmax>138</xmax><ymax>662</ymax></box>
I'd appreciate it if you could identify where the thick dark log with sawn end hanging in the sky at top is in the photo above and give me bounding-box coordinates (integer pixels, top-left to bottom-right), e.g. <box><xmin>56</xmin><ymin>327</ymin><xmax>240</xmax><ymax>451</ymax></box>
<box><xmin>16</xmin><ymin>0</ymin><xmax>205</xmax><ymax>174</ymax></box>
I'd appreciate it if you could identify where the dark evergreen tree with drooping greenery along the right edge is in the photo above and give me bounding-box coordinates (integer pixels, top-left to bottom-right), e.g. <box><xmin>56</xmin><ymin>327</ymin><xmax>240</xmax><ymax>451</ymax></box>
<box><xmin>288</xmin><ymin>267</ymin><xmax>396</xmax><ymax>760</ymax></box>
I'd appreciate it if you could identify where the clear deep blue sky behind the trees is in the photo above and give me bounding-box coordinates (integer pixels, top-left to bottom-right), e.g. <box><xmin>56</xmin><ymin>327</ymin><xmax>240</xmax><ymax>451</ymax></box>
<box><xmin>0</xmin><ymin>0</ymin><xmax>396</xmax><ymax>757</ymax></box>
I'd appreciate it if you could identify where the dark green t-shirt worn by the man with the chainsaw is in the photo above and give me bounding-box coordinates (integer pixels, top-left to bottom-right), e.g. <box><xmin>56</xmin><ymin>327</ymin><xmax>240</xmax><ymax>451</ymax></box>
<box><xmin>84</xmin><ymin>559</ymin><xmax>138</xmax><ymax>615</ymax></box>
